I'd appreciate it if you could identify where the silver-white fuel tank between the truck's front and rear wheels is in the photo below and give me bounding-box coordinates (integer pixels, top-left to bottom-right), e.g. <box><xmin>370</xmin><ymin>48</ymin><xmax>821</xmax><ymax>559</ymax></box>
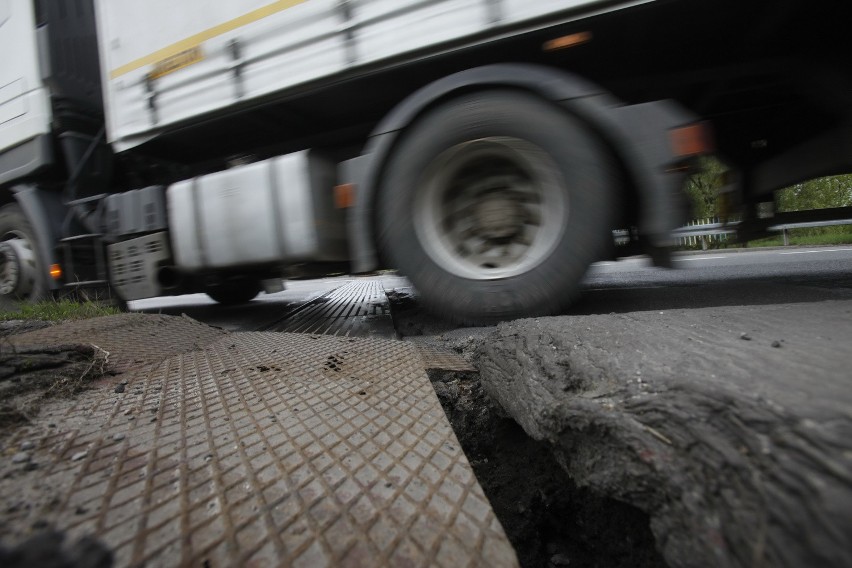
<box><xmin>167</xmin><ymin>150</ymin><xmax>348</xmax><ymax>271</ymax></box>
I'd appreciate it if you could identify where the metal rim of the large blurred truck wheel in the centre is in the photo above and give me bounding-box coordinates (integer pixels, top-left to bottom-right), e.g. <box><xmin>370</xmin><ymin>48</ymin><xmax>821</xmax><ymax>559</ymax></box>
<box><xmin>413</xmin><ymin>137</ymin><xmax>568</xmax><ymax>280</ymax></box>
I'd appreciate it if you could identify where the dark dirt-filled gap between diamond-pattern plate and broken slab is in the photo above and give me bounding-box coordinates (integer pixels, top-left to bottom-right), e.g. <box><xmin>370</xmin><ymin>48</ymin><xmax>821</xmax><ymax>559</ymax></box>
<box><xmin>388</xmin><ymin>288</ymin><xmax>666</xmax><ymax>568</ymax></box>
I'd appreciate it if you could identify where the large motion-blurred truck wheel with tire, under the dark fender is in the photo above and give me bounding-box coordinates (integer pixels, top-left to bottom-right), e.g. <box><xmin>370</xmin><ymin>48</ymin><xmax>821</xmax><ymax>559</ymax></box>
<box><xmin>376</xmin><ymin>91</ymin><xmax>618</xmax><ymax>324</ymax></box>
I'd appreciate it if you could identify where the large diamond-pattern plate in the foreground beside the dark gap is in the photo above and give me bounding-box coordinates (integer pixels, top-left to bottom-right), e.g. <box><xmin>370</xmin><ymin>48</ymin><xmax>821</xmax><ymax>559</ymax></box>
<box><xmin>1</xmin><ymin>333</ymin><xmax>517</xmax><ymax>567</ymax></box>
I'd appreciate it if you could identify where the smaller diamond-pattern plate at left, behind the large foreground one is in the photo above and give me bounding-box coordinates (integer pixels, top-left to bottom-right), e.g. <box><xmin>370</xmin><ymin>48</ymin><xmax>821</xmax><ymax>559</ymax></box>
<box><xmin>5</xmin><ymin>314</ymin><xmax>228</xmax><ymax>371</ymax></box>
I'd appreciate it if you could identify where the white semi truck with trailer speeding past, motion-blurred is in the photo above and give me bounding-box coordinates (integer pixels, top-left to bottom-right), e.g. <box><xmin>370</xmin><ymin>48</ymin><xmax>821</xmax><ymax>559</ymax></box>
<box><xmin>0</xmin><ymin>0</ymin><xmax>852</xmax><ymax>322</ymax></box>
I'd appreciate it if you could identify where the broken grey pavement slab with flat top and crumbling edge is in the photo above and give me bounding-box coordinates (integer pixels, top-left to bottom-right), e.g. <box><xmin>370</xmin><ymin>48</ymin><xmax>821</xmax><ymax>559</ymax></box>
<box><xmin>474</xmin><ymin>301</ymin><xmax>852</xmax><ymax>567</ymax></box>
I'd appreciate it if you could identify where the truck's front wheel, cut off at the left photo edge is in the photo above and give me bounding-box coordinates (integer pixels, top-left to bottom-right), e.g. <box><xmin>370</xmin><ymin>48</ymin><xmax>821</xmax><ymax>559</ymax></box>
<box><xmin>0</xmin><ymin>203</ymin><xmax>49</xmax><ymax>302</ymax></box>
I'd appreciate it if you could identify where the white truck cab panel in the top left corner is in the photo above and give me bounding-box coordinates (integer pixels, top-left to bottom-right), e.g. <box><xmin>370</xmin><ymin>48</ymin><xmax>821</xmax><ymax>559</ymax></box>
<box><xmin>0</xmin><ymin>0</ymin><xmax>51</xmax><ymax>152</ymax></box>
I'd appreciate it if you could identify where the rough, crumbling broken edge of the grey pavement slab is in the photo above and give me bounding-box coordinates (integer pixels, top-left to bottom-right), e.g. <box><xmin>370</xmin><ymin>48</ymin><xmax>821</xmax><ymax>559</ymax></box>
<box><xmin>474</xmin><ymin>324</ymin><xmax>852</xmax><ymax>567</ymax></box>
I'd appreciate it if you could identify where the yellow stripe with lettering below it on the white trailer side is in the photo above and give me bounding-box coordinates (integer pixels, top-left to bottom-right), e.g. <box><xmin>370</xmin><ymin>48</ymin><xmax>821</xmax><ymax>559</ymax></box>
<box><xmin>109</xmin><ymin>0</ymin><xmax>307</xmax><ymax>79</ymax></box>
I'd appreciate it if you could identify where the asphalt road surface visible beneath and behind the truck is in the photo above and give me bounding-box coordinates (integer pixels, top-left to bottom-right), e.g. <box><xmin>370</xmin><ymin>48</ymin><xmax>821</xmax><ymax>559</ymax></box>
<box><xmin>130</xmin><ymin>246</ymin><xmax>852</xmax><ymax>332</ymax></box>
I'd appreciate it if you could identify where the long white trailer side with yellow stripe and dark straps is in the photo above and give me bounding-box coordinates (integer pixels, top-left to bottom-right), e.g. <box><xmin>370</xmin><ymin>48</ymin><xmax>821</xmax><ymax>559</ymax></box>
<box><xmin>97</xmin><ymin>0</ymin><xmax>649</xmax><ymax>150</ymax></box>
